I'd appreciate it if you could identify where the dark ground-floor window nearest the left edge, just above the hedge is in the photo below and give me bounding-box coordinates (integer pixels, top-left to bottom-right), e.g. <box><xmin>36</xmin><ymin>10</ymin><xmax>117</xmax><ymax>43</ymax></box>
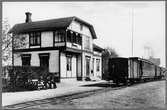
<box><xmin>21</xmin><ymin>54</ymin><xmax>31</xmax><ymax>66</ymax></box>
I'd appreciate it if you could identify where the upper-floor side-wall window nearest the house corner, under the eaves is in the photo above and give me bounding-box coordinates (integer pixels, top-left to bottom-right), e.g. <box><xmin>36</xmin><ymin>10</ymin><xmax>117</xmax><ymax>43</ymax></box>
<box><xmin>54</xmin><ymin>31</ymin><xmax>65</xmax><ymax>42</ymax></box>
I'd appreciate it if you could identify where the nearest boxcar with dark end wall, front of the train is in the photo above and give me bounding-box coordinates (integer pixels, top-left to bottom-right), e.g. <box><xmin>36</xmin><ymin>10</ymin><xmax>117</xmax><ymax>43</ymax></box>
<box><xmin>108</xmin><ymin>57</ymin><xmax>142</xmax><ymax>84</ymax></box>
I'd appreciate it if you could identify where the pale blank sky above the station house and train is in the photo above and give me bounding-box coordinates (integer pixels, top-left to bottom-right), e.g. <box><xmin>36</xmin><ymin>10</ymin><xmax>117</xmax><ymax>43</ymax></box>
<box><xmin>2</xmin><ymin>1</ymin><xmax>165</xmax><ymax>66</ymax></box>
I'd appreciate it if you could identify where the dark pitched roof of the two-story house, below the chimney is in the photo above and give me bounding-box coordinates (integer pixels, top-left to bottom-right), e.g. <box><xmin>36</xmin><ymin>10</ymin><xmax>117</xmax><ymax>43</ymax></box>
<box><xmin>9</xmin><ymin>16</ymin><xmax>97</xmax><ymax>39</ymax></box>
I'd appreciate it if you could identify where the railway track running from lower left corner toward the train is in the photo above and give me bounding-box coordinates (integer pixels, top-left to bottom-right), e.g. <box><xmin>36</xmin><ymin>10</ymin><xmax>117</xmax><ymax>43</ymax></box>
<box><xmin>3</xmin><ymin>79</ymin><xmax>164</xmax><ymax>109</ymax></box>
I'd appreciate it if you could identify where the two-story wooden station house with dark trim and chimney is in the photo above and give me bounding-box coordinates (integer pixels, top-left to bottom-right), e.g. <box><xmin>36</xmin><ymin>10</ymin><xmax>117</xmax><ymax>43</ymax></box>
<box><xmin>9</xmin><ymin>12</ymin><xmax>103</xmax><ymax>80</ymax></box>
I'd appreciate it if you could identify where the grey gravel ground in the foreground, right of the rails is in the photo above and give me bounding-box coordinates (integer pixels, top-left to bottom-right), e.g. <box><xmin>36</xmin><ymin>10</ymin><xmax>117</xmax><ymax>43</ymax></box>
<box><xmin>24</xmin><ymin>80</ymin><xmax>165</xmax><ymax>109</ymax></box>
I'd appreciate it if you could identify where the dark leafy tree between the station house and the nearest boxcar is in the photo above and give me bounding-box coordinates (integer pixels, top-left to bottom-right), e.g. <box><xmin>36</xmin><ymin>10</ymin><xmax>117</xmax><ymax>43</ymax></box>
<box><xmin>102</xmin><ymin>47</ymin><xmax>119</xmax><ymax>80</ymax></box>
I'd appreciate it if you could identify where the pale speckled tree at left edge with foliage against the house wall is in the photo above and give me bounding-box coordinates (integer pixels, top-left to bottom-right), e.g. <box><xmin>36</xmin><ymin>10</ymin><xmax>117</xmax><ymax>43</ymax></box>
<box><xmin>2</xmin><ymin>19</ymin><xmax>27</xmax><ymax>65</ymax></box>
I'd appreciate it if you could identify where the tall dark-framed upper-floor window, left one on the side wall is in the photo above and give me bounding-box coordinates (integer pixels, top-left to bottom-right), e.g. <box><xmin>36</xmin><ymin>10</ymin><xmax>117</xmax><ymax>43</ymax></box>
<box><xmin>29</xmin><ymin>32</ymin><xmax>41</xmax><ymax>46</ymax></box>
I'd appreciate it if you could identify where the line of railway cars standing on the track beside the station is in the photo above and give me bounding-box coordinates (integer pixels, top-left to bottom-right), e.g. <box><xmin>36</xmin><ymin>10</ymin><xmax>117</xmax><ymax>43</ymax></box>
<box><xmin>108</xmin><ymin>57</ymin><xmax>162</xmax><ymax>84</ymax></box>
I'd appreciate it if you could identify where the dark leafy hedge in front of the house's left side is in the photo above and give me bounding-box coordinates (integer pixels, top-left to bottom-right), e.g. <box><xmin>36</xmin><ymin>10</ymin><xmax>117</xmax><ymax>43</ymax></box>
<box><xmin>2</xmin><ymin>66</ymin><xmax>49</xmax><ymax>92</ymax></box>
